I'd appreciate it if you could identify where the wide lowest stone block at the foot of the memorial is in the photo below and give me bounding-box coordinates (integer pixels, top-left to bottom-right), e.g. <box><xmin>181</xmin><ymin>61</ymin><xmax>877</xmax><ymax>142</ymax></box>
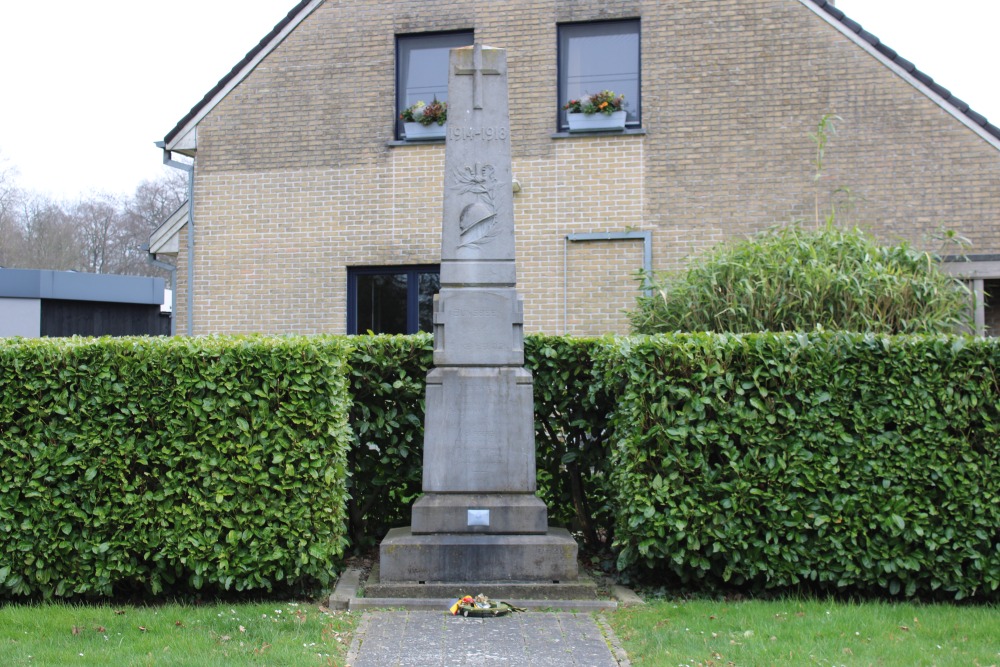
<box><xmin>379</xmin><ymin>526</ymin><xmax>579</xmax><ymax>584</ymax></box>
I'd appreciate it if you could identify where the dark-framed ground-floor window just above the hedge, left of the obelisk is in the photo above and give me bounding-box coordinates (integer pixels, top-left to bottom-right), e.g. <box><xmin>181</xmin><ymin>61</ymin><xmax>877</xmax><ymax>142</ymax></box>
<box><xmin>347</xmin><ymin>265</ymin><xmax>441</xmax><ymax>334</ymax></box>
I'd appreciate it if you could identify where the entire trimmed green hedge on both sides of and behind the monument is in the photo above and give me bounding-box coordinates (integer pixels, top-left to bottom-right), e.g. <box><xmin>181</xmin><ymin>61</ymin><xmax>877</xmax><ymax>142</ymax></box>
<box><xmin>0</xmin><ymin>333</ymin><xmax>1000</xmax><ymax>599</ymax></box>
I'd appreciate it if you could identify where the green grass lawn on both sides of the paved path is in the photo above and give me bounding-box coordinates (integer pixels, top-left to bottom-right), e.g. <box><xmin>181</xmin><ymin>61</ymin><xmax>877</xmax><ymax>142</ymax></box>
<box><xmin>0</xmin><ymin>600</ymin><xmax>1000</xmax><ymax>667</ymax></box>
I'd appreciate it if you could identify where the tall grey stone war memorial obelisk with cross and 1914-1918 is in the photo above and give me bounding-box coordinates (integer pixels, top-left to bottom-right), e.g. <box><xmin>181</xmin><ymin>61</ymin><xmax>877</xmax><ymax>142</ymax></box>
<box><xmin>380</xmin><ymin>44</ymin><xmax>577</xmax><ymax>583</ymax></box>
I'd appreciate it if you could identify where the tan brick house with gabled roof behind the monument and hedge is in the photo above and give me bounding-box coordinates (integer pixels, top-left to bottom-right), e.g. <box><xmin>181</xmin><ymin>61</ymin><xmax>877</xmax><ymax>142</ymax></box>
<box><xmin>151</xmin><ymin>0</ymin><xmax>1000</xmax><ymax>335</ymax></box>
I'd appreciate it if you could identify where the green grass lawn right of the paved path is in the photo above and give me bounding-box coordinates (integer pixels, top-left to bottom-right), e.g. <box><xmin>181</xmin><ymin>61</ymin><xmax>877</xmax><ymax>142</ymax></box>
<box><xmin>608</xmin><ymin>600</ymin><xmax>1000</xmax><ymax>667</ymax></box>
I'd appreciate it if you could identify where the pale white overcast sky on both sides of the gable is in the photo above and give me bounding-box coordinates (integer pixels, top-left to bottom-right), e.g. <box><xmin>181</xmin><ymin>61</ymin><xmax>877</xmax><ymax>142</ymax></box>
<box><xmin>0</xmin><ymin>0</ymin><xmax>1000</xmax><ymax>200</ymax></box>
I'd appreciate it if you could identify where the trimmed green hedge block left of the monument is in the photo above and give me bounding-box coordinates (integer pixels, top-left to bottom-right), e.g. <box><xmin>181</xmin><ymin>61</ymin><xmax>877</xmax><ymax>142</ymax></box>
<box><xmin>0</xmin><ymin>338</ymin><xmax>349</xmax><ymax>597</ymax></box>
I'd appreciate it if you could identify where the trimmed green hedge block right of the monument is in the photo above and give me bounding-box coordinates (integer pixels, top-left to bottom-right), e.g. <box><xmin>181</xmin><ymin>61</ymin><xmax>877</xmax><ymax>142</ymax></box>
<box><xmin>598</xmin><ymin>334</ymin><xmax>1000</xmax><ymax>599</ymax></box>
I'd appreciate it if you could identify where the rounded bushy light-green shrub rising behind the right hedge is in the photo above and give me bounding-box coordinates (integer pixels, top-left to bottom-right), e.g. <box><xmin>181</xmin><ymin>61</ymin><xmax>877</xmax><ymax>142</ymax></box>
<box><xmin>629</xmin><ymin>224</ymin><xmax>971</xmax><ymax>334</ymax></box>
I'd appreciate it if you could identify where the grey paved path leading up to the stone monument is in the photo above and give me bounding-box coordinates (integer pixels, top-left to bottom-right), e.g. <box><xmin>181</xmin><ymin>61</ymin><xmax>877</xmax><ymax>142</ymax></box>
<box><xmin>347</xmin><ymin>611</ymin><xmax>628</xmax><ymax>667</ymax></box>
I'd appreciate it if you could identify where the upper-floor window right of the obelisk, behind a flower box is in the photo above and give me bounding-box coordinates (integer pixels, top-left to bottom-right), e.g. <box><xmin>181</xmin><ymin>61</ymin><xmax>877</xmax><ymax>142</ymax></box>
<box><xmin>558</xmin><ymin>20</ymin><xmax>642</xmax><ymax>130</ymax></box>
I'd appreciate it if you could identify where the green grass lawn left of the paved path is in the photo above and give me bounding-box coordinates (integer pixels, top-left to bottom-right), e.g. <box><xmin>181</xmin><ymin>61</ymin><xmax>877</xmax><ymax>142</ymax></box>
<box><xmin>0</xmin><ymin>602</ymin><xmax>358</xmax><ymax>667</ymax></box>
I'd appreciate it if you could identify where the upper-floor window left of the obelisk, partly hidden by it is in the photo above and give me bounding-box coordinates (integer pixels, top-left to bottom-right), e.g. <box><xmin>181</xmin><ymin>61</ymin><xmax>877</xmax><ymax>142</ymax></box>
<box><xmin>396</xmin><ymin>32</ymin><xmax>472</xmax><ymax>137</ymax></box>
